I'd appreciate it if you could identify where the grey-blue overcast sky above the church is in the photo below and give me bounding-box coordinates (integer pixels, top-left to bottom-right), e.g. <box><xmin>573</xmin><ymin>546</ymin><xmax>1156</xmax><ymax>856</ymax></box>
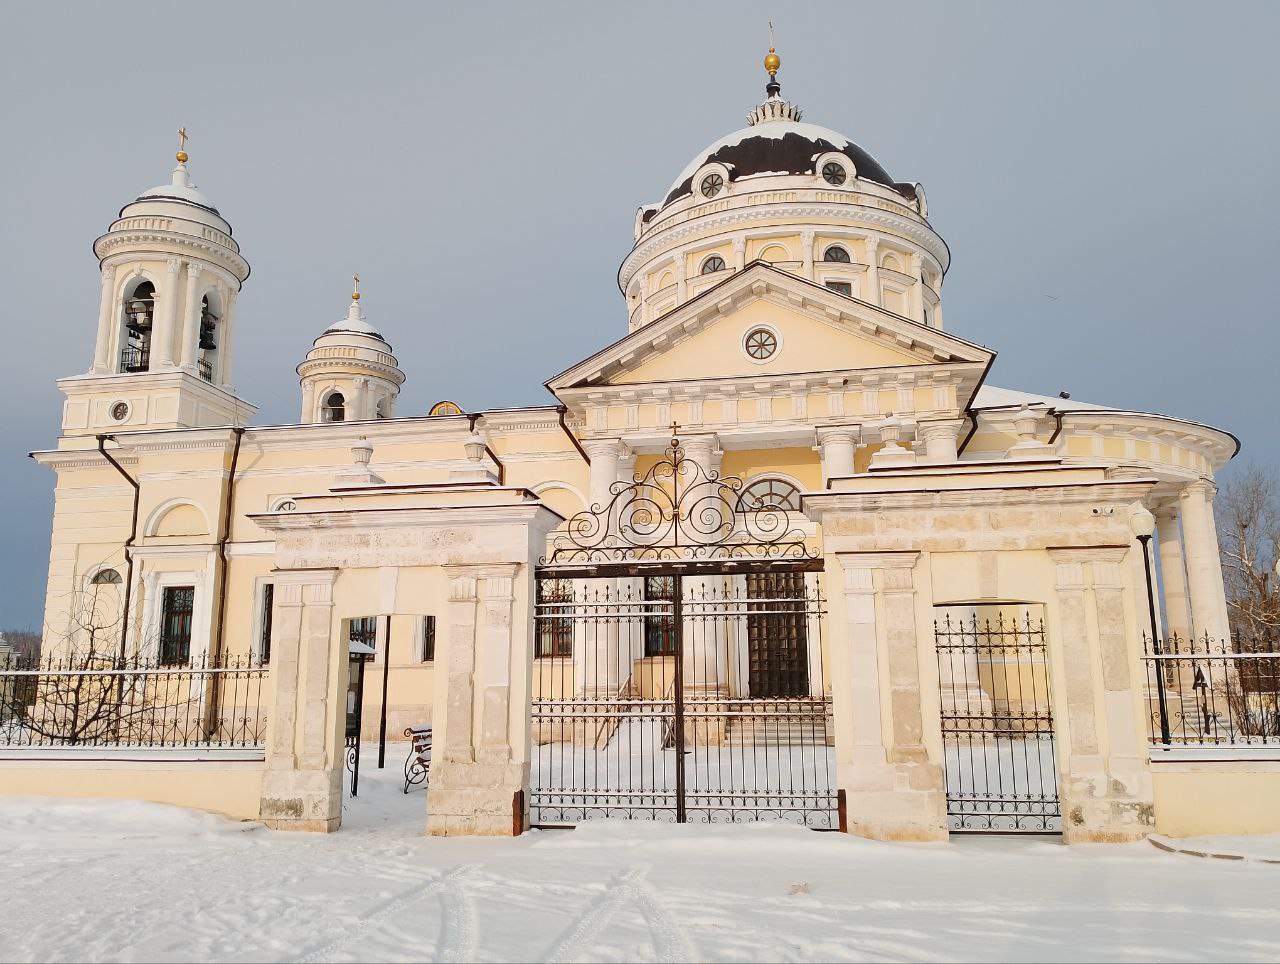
<box><xmin>0</xmin><ymin>0</ymin><xmax>1280</xmax><ymax>629</ymax></box>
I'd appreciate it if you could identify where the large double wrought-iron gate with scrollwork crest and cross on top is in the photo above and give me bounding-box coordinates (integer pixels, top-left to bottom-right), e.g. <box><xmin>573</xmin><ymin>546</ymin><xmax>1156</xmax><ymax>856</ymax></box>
<box><xmin>530</xmin><ymin>439</ymin><xmax>840</xmax><ymax>828</ymax></box>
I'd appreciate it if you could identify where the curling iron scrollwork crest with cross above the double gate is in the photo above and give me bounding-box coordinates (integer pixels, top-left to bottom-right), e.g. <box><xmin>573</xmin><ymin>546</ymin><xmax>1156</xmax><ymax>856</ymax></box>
<box><xmin>540</xmin><ymin>438</ymin><xmax>818</xmax><ymax>566</ymax></box>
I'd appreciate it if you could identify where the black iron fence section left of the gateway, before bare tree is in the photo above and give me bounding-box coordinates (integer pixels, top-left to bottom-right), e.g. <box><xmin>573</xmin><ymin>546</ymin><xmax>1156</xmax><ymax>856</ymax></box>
<box><xmin>0</xmin><ymin>655</ymin><xmax>268</xmax><ymax>750</ymax></box>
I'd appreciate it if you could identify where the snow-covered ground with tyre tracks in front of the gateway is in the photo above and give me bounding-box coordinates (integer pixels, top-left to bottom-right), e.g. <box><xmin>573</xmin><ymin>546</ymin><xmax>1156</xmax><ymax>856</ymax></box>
<box><xmin>0</xmin><ymin>748</ymin><xmax>1280</xmax><ymax>961</ymax></box>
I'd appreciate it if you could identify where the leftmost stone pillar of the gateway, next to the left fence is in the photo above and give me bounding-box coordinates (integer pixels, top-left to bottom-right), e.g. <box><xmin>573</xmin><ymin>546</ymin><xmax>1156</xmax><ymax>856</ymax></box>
<box><xmin>261</xmin><ymin>568</ymin><xmax>347</xmax><ymax>831</ymax></box>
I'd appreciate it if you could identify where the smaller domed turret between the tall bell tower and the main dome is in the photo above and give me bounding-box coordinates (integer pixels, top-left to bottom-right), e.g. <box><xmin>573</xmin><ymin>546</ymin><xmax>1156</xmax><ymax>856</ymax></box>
<box><xmin>298</xmin><ymin>275</ymin><xmax>404</xmax><ymax>424</ymax></box>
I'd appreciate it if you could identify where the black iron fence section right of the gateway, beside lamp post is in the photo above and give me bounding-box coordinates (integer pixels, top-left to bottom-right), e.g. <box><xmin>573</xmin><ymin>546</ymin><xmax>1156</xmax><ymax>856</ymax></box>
<box><xmin>1143</xmin><ymin>636</ymin><xmax>1280</xmax><ymax>749</ymax></box>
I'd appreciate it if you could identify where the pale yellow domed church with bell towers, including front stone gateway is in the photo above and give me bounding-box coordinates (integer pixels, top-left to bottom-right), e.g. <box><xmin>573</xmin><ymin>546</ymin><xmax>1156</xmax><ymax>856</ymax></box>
<box><xmin>19</xmin><ymin>49</ymin><xmax>1280</xmax><ymax>841</ymax></box>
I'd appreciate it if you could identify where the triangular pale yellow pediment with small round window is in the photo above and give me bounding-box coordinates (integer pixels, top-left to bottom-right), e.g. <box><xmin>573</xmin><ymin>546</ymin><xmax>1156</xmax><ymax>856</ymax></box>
<box><xmin>547</xmin><ymin>262</ymin><xmax>995</xmax><ymax>392</ymax></box>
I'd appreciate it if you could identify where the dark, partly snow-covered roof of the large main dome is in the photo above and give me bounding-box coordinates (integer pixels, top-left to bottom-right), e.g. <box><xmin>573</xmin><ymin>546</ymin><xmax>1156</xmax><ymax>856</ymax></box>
<box><xmin>660</xmin><ymin>120</ymin><xmax>915</xmax><ymax>207</ymax></box>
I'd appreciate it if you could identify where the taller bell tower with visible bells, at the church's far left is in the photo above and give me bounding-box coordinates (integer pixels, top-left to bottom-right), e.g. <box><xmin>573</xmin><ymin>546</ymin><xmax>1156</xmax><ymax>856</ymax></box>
<box><xmin>58</xmin><ymin>128</ymin><xmax>257</xmax><ymax>435</ymax></box>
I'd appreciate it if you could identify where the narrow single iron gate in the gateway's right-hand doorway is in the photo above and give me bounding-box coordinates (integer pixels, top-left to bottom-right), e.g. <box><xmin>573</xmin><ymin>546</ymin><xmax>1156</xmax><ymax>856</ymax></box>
<box><xmin>934</xmin><ymin>607</ymin><xmax>1062</xmax><ymax>833</ymax></box>
